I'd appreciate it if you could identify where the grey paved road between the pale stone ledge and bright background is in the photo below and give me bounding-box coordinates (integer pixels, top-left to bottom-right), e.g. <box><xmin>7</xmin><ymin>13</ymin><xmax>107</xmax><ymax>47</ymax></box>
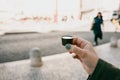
<box><xmin>0</xmin><ymin>32</ymin><xmax>120</xmax><ymax>63</ymax></box>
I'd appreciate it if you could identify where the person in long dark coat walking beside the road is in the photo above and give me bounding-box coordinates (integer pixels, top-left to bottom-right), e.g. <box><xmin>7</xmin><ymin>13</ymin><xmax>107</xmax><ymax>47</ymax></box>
<box><xmin>91</xmin><ymin>12</ymin><xmax>104</xmax><ymax>45</ymax></box>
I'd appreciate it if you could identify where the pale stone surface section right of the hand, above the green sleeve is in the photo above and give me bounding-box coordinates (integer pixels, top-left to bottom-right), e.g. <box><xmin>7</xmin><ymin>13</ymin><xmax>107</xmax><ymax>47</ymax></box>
<box><xmin>95</xmin><ymin>40</ymin><xmax>120</xmax><ymax>68</ymax></box>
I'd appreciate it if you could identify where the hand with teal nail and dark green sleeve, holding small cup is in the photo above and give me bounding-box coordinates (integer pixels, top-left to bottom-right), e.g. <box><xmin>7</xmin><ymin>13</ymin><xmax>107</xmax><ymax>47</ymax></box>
<box><xmin>65</xmin><ymin>38</ymin><xmax>120</xmax><ymax>80</ymax></box>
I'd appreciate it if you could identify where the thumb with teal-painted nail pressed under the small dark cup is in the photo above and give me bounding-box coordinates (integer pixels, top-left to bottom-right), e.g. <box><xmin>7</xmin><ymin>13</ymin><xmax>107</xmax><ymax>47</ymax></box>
<box><xmin>65</xmin><ymin>44</ymin><xmax>85</xmax><ymax>58</ymax></box>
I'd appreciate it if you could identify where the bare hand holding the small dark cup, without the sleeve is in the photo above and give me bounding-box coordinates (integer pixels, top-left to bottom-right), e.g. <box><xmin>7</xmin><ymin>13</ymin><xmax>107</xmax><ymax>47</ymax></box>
<box><xmin>66</xmin><ymin>38</ymin><xmax>99</xmax><ymax>75</ymax></box>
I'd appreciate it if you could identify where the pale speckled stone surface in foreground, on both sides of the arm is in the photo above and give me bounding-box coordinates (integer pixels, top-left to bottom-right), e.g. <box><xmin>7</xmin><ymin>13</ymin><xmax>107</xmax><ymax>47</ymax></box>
<box><xmin>0</xmin><ymin>41</ymin><xmax>120</xmax><ymax>80</ymax></box>
